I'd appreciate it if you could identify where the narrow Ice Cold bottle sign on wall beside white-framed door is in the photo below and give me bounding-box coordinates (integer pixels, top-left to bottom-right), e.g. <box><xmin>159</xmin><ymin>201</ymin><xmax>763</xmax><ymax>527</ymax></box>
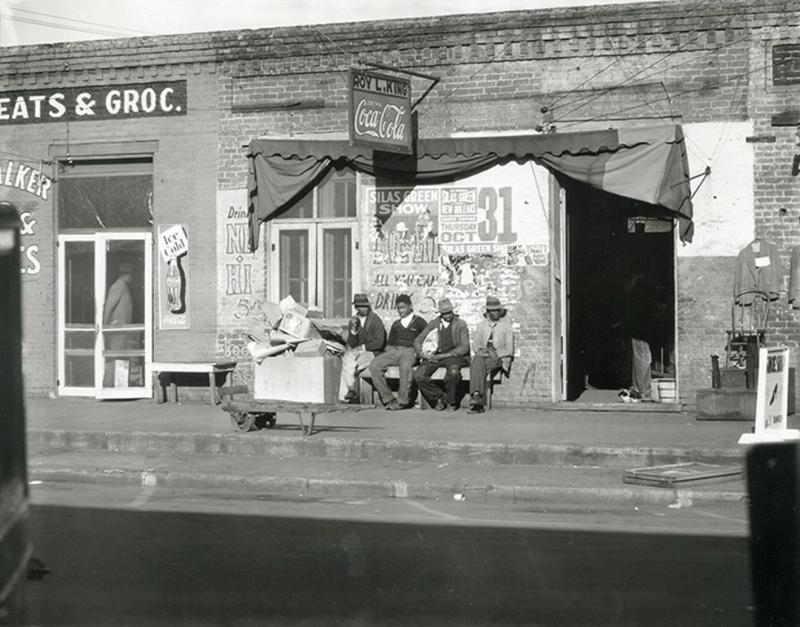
<box><xmin>158</xmin><ymin>224</ymin><xmax>189</xmax><ymax>331</ymax></box>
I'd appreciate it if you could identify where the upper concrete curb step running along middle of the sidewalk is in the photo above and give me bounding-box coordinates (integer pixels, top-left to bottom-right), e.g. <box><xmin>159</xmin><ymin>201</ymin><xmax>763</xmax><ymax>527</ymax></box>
<box><xmin>28</xmin><ymin>429</ymin><xmax>744</xmax><ymax>467</ymax></box>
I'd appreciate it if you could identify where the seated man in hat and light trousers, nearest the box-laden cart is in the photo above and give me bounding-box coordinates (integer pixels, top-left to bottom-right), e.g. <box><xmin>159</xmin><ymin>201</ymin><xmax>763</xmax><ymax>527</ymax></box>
<box><xmin>339</xmin><ymin>294</ymin><xmax>386</xmax><ymax>404</ymax></box>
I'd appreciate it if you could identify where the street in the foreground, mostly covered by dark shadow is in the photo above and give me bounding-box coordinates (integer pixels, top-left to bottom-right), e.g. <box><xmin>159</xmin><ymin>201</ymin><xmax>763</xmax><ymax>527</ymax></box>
<box><xmin>21</xmin><ymin>486</ymin><xmax>753</xmax><ymax>627</ymax></box>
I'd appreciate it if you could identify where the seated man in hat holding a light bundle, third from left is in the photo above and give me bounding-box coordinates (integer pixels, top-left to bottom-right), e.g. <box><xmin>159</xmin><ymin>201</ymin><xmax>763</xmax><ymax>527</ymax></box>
<box><xmin>414</xmin><ymin>298</ymin><xmax>469</xmax><ymax>411</ymax></box>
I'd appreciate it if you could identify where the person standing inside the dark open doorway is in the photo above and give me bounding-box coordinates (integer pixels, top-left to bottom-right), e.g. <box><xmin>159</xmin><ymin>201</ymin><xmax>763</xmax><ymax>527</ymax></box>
<box><xmin>619</xmin><ymin>274</ymin><xmax>655</xmax><ymax>403</ymax></box>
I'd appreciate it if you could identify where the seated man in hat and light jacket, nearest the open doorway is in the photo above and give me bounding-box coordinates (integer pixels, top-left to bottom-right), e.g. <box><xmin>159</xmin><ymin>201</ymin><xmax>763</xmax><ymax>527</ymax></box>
<box><xmin>469</xmin><ymin>296</ymin><xmax>514</xmax><ymax>414</ymax></box>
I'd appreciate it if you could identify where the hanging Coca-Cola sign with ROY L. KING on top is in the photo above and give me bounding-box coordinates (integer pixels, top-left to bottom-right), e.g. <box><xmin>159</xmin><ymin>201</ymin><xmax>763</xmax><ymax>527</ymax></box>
<box><xmin>349</xmin><ymin>69</ymin><xmax>413</xmax><ymax>154</ymax></box>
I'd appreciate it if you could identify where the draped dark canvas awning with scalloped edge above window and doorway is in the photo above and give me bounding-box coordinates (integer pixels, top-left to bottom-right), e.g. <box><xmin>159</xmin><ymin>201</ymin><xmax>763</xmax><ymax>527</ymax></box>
<box><xmin>247</xmin><ymin>126</ymin><xmax>693</xmax><ymax>250</ymax></box>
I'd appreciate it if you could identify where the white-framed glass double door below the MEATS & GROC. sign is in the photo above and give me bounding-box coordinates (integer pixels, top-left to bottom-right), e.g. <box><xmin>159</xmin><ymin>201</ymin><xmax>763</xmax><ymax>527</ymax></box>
<box><xmin>58</xmin><ymin>232</ymin><xmax>153</xmax><ymax>399</ymax></box>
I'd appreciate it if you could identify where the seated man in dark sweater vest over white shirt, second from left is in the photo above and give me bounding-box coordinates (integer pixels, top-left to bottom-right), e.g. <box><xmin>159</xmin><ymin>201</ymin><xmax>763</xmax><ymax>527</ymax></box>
<box><xmin>369</xmin><ymin>294</ymin><xmax>427</xmax><ymax>410</ymax></box>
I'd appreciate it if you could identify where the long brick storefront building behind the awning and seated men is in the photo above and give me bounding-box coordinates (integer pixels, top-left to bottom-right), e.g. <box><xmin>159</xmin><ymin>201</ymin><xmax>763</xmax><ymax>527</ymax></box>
<box><xmin>0</xmin><ymin>0</ymin><xmax>800</xmax><ymax>407</ymax></box>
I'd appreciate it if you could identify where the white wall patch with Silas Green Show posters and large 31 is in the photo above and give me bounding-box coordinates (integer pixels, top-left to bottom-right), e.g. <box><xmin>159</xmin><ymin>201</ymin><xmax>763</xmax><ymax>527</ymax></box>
<box><xmin>362</xmin><ymin>164</ymin><xmax>550</xmax><ymax>315</ymax></box>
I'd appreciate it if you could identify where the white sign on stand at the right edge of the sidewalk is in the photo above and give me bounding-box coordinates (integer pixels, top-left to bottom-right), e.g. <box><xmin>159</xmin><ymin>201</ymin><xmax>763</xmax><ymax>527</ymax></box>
<box><xmin>739</xmin><ymin>346</ymin><xmax>800</xmax><ymax>444</ymax></box>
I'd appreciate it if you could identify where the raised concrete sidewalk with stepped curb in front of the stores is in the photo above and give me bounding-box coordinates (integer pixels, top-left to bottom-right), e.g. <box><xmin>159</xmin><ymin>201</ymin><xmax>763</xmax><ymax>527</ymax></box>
<box><xmin>27</xmin><ymin>398</ymin><xmax>764</xmax><ymax>503</ymax></box>
